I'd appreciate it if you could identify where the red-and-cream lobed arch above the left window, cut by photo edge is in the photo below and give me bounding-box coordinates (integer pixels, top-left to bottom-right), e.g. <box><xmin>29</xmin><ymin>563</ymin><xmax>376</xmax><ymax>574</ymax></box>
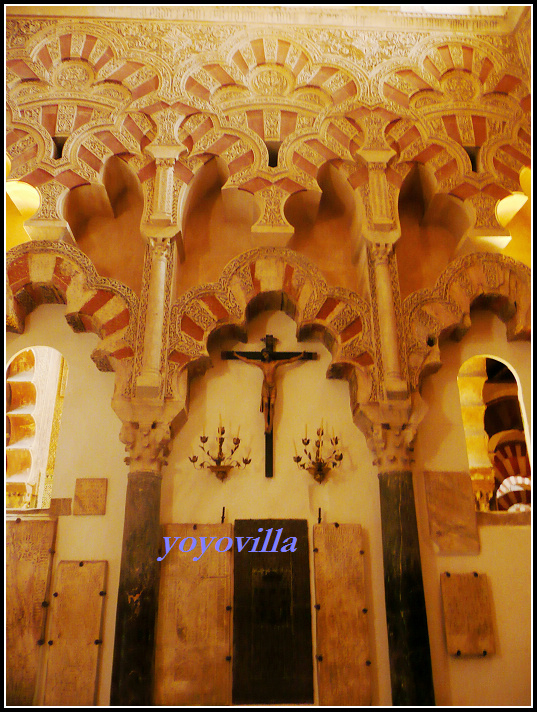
<box><xmin>6</xmin><ymin>241</ymin><xmax>138</xmax><ymax>371</ymax></box>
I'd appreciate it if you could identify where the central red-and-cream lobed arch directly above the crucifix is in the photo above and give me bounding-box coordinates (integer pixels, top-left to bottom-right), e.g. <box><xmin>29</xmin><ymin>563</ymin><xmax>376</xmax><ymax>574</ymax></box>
<box><xmin>166</xmin><ymin>247</ymin><xmax>378</xmax><ymax>409</ymax></box>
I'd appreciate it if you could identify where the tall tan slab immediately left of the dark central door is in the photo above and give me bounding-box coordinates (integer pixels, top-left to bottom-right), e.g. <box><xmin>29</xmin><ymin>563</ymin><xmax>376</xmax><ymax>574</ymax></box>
<box><xmin>155</xmin><ymin>524</ymin><xmax>233</xmax><ymax>706</ymax></box>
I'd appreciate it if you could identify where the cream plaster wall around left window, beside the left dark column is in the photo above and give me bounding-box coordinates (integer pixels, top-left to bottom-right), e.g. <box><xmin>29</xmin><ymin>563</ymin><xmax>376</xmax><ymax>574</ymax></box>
<box><xmin>6</xmin><ymin>305</ymin><xmax>127</xmax><ymax>706</ymax></box>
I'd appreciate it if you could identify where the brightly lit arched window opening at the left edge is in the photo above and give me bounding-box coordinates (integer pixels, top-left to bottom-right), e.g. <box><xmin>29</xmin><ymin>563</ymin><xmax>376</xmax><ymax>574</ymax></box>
<box><xmin>6</xmin><ymin>346</ymin><xmax>67</xmax><ymax>510</ymax></box>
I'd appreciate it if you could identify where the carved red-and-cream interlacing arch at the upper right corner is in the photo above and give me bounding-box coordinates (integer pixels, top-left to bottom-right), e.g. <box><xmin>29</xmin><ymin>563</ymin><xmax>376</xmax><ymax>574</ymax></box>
<box><xmin>382</xmin><ymin>38</ymin><xmax>531</xmax><ymax>217</ymax></box>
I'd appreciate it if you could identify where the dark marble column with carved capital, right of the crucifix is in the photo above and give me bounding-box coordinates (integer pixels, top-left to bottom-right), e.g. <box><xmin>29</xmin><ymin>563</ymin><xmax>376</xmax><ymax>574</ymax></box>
<box><xmin>355</xmin><ymin>404</ymin><xmax>434</xmax><ymax>707</ymax></box>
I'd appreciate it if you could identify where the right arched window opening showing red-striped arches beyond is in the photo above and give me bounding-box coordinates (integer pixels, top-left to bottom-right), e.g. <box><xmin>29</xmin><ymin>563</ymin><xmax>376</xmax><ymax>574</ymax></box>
<box><xmin>457</xmin><ymin>356</ymin><xmax>531</xmax><ymax>512</ymax></box>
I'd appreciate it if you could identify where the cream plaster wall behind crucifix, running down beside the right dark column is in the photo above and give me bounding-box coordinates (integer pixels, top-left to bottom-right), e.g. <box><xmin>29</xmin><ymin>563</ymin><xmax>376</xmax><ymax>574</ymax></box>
<box><xmin>161</xmin><ymin>312</ymin><xmax>391</xmax><ymax>705</ymax></box>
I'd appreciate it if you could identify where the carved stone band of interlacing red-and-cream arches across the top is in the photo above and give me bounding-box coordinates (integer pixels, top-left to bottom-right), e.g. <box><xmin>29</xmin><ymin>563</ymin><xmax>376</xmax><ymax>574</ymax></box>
<box><xmin>8</xmin><ymin>18</ymin><xmax>529</xmax><ymax>242</ymax></box>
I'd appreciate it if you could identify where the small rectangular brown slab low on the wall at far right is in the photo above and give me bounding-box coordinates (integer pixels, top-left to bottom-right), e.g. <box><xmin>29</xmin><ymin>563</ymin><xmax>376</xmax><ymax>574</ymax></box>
<box><xmin>440</xmin><ymin>572</ymin><xmax>496</xmax><ymax>657</ymax></box>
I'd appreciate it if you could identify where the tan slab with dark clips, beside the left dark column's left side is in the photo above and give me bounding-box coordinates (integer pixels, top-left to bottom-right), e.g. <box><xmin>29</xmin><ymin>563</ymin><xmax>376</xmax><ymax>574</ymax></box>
<box><xmin>43</xmin><ymin>561</ymin><xmax>107</xmax><ymax>706</ymax></box>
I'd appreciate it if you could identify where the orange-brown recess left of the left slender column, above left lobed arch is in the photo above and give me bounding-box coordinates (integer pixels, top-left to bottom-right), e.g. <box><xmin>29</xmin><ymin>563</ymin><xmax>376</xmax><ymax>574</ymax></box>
<box><xmin>63</xmin><ymin>156</ymin><xmax>145</xmax><ymax>296</ymax></box>
